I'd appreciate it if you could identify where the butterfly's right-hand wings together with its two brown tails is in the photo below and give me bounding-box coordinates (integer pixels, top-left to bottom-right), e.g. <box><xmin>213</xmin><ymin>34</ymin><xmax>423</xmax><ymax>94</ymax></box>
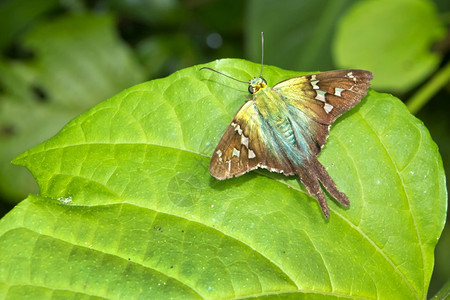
<box><xmin>273</xmin><ymin>70</ymin><xmax>373</xmax><ymax>218</ymax></box>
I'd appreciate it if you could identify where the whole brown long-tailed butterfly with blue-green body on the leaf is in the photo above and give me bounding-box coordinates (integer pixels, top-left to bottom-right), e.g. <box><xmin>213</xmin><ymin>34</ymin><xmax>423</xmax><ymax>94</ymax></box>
<box><xmin>202</xmin><ymin>34</ymin><xmax>373</xmax><ymax>218</ymax></box>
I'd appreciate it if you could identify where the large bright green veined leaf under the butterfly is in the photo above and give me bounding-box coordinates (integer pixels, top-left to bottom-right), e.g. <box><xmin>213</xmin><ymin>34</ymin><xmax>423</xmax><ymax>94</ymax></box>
<box><xmin>0</xmin><ymin>60</ymin><xmax>447</xmax><ymax>299</ymax></box>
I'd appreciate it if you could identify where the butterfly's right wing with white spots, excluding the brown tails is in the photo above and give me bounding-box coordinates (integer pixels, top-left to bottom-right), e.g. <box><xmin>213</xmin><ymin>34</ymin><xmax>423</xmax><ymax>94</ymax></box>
<box><xmin>273</xmin><ymin>70</ymin><xmax>373</xmax><ymax>155</ymax></box>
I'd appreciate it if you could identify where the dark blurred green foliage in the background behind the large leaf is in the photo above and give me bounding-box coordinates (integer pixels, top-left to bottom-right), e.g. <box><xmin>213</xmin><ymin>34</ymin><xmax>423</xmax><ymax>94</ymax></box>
<box><xmin>0</xmin><ymin>0</ymin><xmax>450</xmax><ymax>296</ymax></box>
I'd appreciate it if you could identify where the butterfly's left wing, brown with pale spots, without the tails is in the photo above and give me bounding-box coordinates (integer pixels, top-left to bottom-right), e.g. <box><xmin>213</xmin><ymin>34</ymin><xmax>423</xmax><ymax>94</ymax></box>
<box><xmin>209</xmin><ymin>100</ymin><xmax>295</xmax><ymax>180</ymax></box>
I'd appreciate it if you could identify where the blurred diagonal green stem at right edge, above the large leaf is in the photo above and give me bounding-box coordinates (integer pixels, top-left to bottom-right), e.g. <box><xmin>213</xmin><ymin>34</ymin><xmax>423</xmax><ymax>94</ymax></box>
<box><xmin>406</xmin><ymin>62</ymin><xmax>450</xmax><ymax>114</ymax></box>
